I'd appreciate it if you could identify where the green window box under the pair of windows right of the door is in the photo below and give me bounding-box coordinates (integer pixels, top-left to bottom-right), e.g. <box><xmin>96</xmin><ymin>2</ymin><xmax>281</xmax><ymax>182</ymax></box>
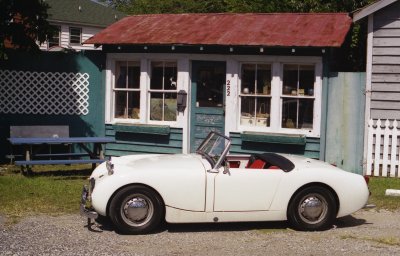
<box><xmin>240</xmin><ymin>132</ymin><xmax>306</xmax><ymax>145</ymax></box>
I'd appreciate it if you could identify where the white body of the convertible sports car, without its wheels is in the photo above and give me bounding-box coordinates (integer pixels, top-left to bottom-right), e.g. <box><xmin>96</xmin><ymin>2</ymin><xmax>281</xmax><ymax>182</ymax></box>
<box><xmin>81</xmin><ymin>132</ymin><xmax>369</xmax><ymax>234</ymax></box>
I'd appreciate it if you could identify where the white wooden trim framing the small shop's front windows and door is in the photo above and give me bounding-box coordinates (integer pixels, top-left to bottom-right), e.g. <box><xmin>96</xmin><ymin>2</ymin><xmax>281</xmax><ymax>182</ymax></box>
<box><xmin>105</xmin><ymin>53</ymin><xmax>322</xmax><ymax>139</ymax></box>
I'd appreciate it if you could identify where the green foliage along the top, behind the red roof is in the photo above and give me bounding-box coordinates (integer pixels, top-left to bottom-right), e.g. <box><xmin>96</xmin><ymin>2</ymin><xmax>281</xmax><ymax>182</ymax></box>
<box><xmin>103</xmin><ymin>0</ymin><xmax>373</xmax><ymax>14</ymax></box>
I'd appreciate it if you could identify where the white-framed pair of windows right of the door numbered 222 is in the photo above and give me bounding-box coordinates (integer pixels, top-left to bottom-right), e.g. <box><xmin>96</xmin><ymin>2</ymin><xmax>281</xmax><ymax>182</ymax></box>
<box><xmin>238</xmin><ymin>63</ymin><xmax>321</xmax><ymax>136</ymax></box>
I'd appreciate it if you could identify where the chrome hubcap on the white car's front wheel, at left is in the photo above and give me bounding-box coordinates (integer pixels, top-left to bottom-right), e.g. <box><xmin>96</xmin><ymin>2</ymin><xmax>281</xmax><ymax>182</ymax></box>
<box><xmin>121</xmin><ymin>195</ymin><xmax>154</xmax><ymax>226</ymax></box>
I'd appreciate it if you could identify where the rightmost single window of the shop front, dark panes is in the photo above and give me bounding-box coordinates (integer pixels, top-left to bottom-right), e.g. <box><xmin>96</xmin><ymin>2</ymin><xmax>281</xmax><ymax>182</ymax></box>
<box><xmin>281</xmin><ymin>65</ymin><xmax>315</xmax><ymax>129</ymax></box>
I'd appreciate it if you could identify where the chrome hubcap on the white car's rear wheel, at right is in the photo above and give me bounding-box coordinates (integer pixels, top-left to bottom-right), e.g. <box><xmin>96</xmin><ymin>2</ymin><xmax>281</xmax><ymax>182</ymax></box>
<box><xmin>298</xmin><ymin>195</ymin><xmax>328</xmax><ymax>224</ymax></box>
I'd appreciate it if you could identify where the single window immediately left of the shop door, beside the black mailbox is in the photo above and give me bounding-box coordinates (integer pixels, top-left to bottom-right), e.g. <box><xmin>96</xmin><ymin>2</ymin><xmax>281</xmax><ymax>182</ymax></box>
<box><xmin>149</xmin><ymin>61</ymin><xmax>177</xmax><ymax>121</ymax></box>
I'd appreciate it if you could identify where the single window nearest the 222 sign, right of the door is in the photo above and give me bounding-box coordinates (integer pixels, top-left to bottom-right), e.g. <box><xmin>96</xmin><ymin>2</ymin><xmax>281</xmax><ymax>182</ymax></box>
<box><xmin>240</xmin><ymin>64</ymin><xmax>271</xmax><ymax>127</ymax></box>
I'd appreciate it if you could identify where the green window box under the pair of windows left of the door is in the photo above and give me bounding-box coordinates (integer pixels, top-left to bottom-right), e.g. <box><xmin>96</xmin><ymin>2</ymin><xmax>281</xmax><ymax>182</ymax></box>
<box><xmin>113</xmin><ymin>124</ymin><xmax>170</xmax><ymax>135</ymax></box>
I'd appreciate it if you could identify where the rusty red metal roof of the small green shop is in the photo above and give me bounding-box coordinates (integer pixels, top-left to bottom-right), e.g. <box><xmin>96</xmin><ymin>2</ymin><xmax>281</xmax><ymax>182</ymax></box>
<box><xmin>85</xmin><ymin>13</ymin><xmax>351</xmax><ymax>47</ymax></box>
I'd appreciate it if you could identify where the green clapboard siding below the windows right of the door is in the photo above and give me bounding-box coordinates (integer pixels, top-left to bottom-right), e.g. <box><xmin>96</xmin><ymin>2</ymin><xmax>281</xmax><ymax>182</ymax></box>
<box><xmin>230</xmin><ymin>133</ymin><xmax>320</xmax><ymax>159</ymax></box>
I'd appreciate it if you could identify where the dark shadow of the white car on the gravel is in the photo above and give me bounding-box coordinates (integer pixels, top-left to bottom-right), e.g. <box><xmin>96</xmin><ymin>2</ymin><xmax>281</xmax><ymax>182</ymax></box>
<box><xmin>92</xmin><ymin>215</ymin><xmax>370</xmax><ymax>233</ymax></box>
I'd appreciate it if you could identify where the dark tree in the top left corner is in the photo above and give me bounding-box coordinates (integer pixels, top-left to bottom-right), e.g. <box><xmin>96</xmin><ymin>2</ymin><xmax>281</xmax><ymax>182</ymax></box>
<box><xmin>0</xmin><ymin>0</ymin><xmax>55</xmax><ymax>59</ymax></box>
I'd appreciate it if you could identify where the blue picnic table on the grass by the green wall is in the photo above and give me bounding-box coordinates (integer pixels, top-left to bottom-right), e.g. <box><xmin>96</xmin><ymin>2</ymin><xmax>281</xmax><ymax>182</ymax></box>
<box><xmin>8</xmin><ymin>137</ymin><xmax>115</xmax><ymax>171</ymax></box>
